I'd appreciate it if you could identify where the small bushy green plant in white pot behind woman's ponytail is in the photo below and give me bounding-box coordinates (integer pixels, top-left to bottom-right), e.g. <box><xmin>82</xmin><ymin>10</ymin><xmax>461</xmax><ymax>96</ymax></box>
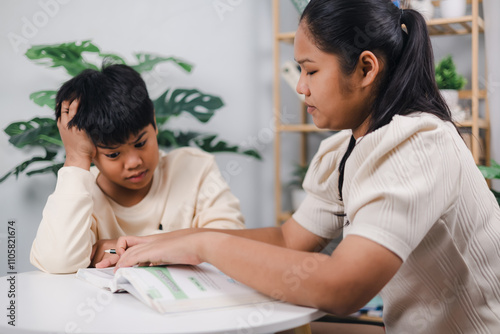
<box><xmin>435</xmin><ymin>55</ymin><xmax>467</xmax><ymax>121</ymax></box>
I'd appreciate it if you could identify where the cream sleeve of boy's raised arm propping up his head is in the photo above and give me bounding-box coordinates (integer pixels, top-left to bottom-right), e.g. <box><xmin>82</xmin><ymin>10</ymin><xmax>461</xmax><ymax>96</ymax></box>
<box><xmin>30</xmin><ymin>167</ymin><xmax>96</xmax><ymax>273</ymax></box>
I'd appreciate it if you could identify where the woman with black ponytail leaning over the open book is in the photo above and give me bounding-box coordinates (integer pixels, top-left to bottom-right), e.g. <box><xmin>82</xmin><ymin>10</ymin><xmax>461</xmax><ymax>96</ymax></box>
<box><xmin>113</xmin><ymin>0</ymin><xmax>500</xmax><ymax>334</ymax></box>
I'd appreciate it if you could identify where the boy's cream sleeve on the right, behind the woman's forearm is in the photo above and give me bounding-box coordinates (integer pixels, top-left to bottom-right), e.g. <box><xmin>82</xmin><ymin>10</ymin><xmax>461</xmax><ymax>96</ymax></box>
<box><xmin>192</xmin><ymin>157</ymin><xmax>245</xmax><ymax>229</ymax></box>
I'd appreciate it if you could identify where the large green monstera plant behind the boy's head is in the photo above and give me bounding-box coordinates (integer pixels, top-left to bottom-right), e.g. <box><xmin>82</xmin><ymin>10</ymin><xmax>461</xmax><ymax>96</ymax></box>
<box><xmin>0</xmin><ymin>40</ymin><xmax>261</xmax><ymax>183</ymax></box>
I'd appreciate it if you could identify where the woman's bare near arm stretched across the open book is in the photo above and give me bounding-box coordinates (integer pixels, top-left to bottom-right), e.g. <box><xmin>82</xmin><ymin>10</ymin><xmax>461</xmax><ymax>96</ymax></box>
<box><xmin>117</xmin><ymin>224</ymin><xmax>402</xmax><ymax>315</ymax></box>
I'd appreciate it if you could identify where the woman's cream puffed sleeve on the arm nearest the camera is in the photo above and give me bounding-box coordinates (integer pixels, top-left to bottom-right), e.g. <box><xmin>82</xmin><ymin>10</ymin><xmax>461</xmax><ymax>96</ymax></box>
<box><xmin>344</xmin><ymin>117</ymin><xmax>461</xmax><ymax>261</ymax></box>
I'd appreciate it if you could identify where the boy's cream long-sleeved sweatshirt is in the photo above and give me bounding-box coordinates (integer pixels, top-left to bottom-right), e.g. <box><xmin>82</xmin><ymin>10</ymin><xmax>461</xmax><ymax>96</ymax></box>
<box><xmin>30</xmin><ymin>148</ymin><xmax>244</xmax><ymax>273</ymax></box>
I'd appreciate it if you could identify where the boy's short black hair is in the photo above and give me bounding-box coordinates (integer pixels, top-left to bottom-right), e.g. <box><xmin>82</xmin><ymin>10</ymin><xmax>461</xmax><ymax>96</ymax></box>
<box><xmin>55</xmin><ymin>64</ymin><xmax>155</xmax><ymax>146</ymax></box>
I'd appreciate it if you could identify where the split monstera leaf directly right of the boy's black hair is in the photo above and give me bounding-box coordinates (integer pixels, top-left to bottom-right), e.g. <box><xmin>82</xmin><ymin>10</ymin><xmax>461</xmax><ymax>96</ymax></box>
<box><xmin>154</xmin><ymin>89</ymin><xmax>224</xmax><ymax>125</ymax></box>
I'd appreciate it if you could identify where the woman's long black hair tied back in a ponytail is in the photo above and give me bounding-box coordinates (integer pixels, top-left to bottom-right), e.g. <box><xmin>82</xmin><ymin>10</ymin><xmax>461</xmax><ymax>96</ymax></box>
<box><xmin>300</xmin><ymin>0</ymin><xmax>452</xmax><ymax>199</ymax></box>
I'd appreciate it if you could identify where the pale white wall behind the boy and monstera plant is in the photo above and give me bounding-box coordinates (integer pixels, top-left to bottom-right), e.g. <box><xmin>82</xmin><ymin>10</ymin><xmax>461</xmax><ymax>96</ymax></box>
<box><xmin>0</xmin><ymin>0</ymin><xmax>274</xmax><ymax>275</ymax></box>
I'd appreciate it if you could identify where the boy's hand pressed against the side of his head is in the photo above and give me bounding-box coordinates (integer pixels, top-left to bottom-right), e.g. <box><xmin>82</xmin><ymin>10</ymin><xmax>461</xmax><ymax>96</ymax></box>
<box><xmin>57</xmin><ymin>100</ymin><xmax>97</xmax><ymax>170</ymax></box>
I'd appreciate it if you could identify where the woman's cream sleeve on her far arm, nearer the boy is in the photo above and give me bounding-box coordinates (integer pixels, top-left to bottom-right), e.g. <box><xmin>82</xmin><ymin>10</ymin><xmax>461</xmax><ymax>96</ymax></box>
<box><xmin>292</xmin><ymin>131</ymin><xmax>351</xmax><ymax>239</ymax></box>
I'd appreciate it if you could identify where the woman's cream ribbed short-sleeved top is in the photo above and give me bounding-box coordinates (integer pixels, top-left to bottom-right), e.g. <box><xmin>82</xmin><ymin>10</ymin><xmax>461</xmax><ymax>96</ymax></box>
<box><xmin>293</xmin><ymin>113</ymin><xmax>500</xmax><ymax>334</ymax></box>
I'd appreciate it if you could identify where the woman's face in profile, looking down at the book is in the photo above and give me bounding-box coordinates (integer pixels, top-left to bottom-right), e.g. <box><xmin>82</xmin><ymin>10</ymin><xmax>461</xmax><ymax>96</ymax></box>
<box><xmin>294</xmin><ymin>23</ymin><xmax>371</xmax><ymax>138</ymax></box>
